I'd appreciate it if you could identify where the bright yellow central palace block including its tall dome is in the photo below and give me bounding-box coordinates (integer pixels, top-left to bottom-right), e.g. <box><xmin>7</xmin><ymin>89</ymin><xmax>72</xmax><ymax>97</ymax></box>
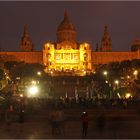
<box><xmin>43</xmin><ymin>11</ymin><xmax>92</xmax><ymax>75</ymax></box>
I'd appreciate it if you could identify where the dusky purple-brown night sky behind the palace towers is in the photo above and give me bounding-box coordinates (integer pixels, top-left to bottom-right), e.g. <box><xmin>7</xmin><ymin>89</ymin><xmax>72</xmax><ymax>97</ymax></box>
<box><xmin>0</xmin><ymin>1</ymin><xmax>140</xmax><ymax>51</ymax></box>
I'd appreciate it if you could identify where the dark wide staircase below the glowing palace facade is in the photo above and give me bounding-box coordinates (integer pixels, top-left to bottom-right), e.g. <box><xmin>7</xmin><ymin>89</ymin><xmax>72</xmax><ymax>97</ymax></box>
<box><xmin>50</xmin><ymin>77</ymin><xmax>91</xmax><ymax>97</ymax></box>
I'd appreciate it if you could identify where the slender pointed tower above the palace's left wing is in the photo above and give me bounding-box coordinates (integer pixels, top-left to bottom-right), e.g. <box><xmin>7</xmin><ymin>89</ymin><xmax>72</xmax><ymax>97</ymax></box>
<box><xmin>20</xmin><ymin>25</ymin><xmax>33</xmax><ymax>52</ymax></box>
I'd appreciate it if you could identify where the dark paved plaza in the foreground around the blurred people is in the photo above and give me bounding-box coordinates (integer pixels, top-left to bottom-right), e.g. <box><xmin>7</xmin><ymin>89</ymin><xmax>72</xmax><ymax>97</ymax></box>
<box><xmin>0</xmin><ymin>107</ymin><xmax>140</xmax><ymax>139</ymax></box>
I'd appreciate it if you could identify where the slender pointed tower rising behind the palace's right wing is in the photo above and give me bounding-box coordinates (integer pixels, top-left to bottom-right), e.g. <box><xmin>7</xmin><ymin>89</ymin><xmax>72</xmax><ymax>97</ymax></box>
<box><xmin>100</xmin><ymin>26</ymin><xmax>112</xmax><ymax>52</ymax></box>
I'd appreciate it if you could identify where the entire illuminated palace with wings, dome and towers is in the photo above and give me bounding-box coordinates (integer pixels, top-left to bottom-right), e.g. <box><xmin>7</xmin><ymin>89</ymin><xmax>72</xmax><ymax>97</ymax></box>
<box><xmin>0</xmin><ymin>12</ymin><xmax>140</xmax><ymax>75</ymax></box>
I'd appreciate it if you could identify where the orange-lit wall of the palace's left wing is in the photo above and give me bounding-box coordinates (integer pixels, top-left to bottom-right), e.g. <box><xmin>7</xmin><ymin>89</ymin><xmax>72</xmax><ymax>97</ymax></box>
<box><xmin>0</xmin><ymin>51</ymin><xmax>43</xmax><ymax>64</ymax></box>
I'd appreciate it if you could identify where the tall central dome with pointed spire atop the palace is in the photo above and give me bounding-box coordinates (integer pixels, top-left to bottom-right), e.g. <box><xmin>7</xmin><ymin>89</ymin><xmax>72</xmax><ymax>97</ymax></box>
<box><xmin>57</xmin><ymin>11</ymin><xmax>76</xmax><ymax>43</ymax></box>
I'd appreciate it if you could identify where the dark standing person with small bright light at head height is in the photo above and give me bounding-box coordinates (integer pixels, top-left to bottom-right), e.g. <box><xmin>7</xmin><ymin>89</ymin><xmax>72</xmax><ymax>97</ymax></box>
<box><xmin>82</xmin><ymin>112</ymin><xmax>89</xmax><ymax>137</ymax></box>
